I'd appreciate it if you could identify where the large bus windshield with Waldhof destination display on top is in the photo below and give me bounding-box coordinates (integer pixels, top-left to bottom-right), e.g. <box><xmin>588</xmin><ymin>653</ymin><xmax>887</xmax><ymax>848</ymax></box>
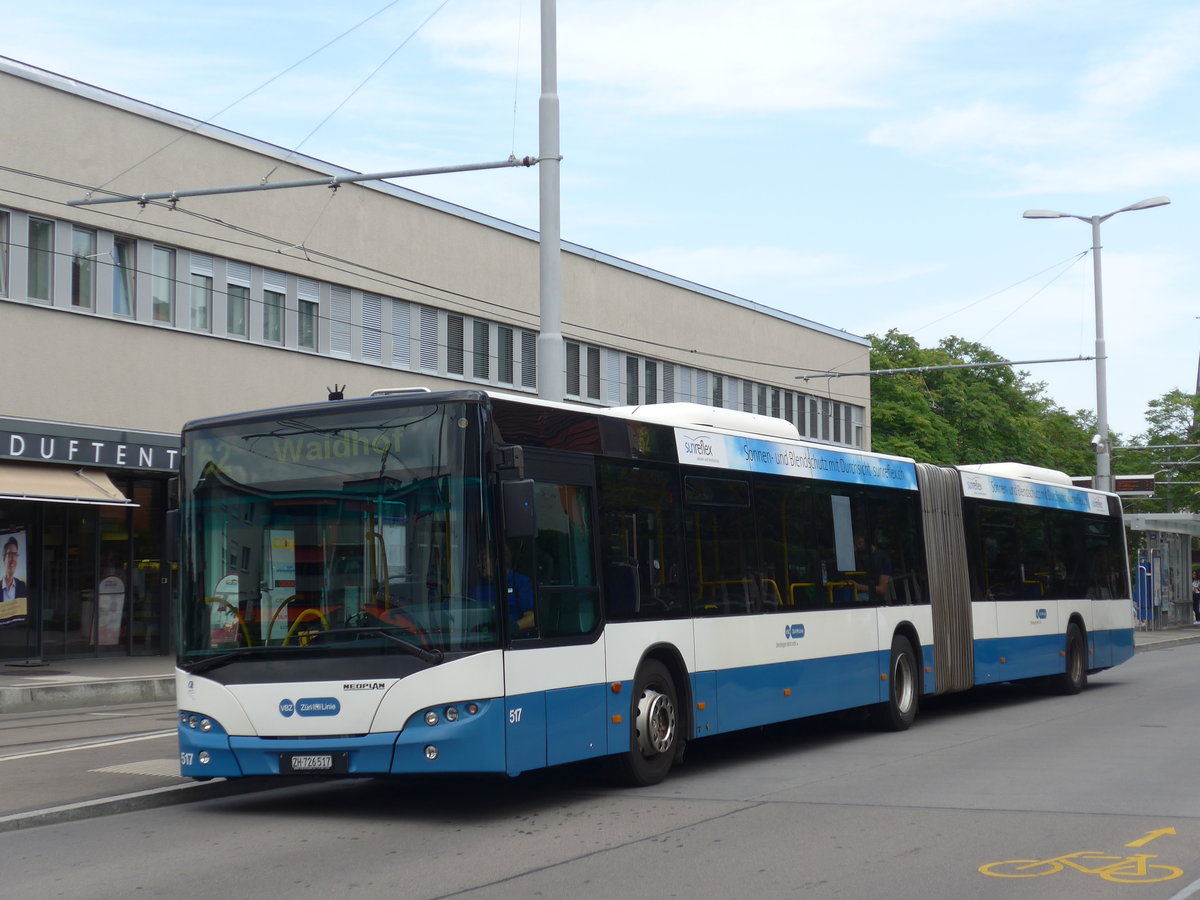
<box><xmin>179</xmin><ymin>402</ymin><xmax>499</xmax><ymax>665</ymax></box>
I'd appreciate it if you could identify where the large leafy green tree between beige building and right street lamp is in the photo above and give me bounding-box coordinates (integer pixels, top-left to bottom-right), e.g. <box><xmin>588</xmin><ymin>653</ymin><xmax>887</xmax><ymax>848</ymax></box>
<box><xmin>870</xmin><ymin>329</ymin><xmax>1096</xmax><ymax>475</ymax></box>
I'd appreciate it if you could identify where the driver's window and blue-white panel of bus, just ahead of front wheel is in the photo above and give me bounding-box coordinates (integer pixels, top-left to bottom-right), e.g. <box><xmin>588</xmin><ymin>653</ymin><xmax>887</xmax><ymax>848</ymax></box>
<box><xmin>504</xmin><ymin>449</ymin><xmax>607</xmax><ymax>772</ymax></box>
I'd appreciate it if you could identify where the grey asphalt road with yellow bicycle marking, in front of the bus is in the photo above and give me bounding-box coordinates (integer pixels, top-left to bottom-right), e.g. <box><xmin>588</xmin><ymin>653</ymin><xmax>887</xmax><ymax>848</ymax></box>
<box><xmin>0</xmin><ymin>644</ymin><xmax>1200</xmax><ymax>900</ymax></box>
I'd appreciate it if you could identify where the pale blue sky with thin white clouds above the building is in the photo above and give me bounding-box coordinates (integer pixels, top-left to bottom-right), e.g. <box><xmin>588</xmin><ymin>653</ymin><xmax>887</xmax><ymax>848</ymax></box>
<box><xmin>7</xmin><ymin>0</ymin><xmax>1200</xmax><ymax>438</ymax></box>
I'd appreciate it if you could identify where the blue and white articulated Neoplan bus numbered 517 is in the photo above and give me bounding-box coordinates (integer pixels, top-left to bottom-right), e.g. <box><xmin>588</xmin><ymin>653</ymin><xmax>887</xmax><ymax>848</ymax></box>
<box><xmin>176</xmin><ymin>390</ymin><xmax>1133</xmax><ymax>785</ymax></box>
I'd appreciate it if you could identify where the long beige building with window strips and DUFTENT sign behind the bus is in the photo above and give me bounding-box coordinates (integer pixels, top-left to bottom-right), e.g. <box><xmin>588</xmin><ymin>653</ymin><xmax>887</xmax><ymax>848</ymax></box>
<box><xmin>0</xmin><ymin>60</ymin><xmax>870</xmax><ymax>660</ymax></box>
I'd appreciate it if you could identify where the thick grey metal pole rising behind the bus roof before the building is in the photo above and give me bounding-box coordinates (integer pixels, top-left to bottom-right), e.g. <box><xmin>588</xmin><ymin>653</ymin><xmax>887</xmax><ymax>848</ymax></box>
<box><xmin>538</xmin><ymin>0</ymin><xmax>566</xmax><ymax>401</ymax></box>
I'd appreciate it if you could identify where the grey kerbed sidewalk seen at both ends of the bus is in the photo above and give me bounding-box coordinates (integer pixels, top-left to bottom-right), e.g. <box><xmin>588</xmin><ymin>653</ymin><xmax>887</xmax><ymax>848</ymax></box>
<box><xmin>7</xmin><ymin>625</ymin><xmax>1200</xmax><ymax>713</ymax></box>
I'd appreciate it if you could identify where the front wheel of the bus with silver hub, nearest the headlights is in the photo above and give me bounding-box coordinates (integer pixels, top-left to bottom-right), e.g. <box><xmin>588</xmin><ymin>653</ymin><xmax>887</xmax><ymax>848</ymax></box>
<box><xmin>619</xmin><ymin>660</ymin><xmax>683</xmax><ymax>787</ymax></box>
